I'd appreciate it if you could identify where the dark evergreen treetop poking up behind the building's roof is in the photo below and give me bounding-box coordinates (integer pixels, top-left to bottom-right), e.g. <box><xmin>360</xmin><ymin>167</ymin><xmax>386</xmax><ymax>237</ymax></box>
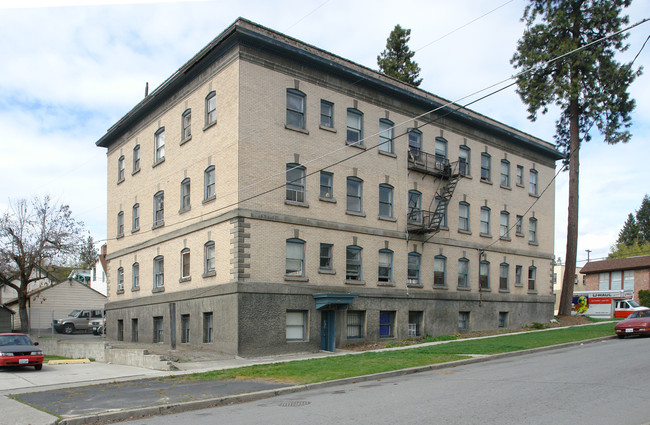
<box><xmin>377</xmin><ymin>24</ymin><xmax>422</xmax><ymax>87</ymax></box>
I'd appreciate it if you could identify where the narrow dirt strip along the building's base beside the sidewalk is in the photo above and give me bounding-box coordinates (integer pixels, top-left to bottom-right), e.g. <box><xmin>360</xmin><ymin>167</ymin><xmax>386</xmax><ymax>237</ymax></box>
<box><xmin>345</xmin><ymin>316</ymin><xmax>593</xmax><ymax>351</ymax></box>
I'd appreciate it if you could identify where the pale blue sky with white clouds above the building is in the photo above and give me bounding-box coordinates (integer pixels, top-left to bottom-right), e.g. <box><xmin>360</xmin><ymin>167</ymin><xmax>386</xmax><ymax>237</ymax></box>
<box><xmin>0</xmin><ymin>0</ymin><xmax>650</xmax><ymax>265</ymax></box>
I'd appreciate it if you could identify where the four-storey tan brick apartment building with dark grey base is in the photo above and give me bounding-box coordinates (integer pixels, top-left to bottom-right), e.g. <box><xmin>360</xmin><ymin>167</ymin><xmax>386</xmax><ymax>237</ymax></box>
<box><xmin>97</xmin><ymin>19</ymin><xmax>561</xmax><ymax>356</ymax></box>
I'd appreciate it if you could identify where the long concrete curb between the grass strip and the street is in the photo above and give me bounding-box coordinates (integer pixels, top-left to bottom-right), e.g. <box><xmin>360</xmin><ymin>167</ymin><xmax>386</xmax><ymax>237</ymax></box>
<box><xmin>57</xmin><ymin>335</ymin><xmax>616</xmax><ymax>425</ymax></box>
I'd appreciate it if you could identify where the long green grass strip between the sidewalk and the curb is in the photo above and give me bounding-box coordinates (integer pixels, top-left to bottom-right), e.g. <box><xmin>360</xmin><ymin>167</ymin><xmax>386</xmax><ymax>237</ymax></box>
<box><xmin>181</xmin><ymin>323</ymin><xmax>615</xmax><ymax>384</ymax></box>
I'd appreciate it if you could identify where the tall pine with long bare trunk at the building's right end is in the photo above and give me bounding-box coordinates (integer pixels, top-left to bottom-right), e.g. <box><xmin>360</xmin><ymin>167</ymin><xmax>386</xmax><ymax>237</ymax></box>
<box><xmin>511</xmin><ymin>0</ymin><xmax>640</xmax><ymax>315</ymax></box>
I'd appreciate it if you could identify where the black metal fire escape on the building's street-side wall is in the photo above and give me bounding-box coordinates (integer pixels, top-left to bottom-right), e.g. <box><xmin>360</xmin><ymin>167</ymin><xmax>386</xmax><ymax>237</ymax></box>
<box><xmin>407</xmin><ymin>149</ymin><xmax>460</xmax><ymax>234</ymax></box>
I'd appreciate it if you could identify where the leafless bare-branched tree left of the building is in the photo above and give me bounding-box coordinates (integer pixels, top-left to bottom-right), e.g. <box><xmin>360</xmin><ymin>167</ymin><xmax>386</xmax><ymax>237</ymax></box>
<box><xmin>0</xmin><ymin>196</ymin><xmax>83</xmax><ymax>332</ymax></box>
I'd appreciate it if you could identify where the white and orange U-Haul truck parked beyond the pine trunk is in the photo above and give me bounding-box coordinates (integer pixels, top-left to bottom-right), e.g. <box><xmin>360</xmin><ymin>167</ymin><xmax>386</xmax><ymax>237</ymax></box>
<box><xmin>571</xmin><ymin>289</ymin><xmax>650</xmax><ymax>318</ymax></box>
